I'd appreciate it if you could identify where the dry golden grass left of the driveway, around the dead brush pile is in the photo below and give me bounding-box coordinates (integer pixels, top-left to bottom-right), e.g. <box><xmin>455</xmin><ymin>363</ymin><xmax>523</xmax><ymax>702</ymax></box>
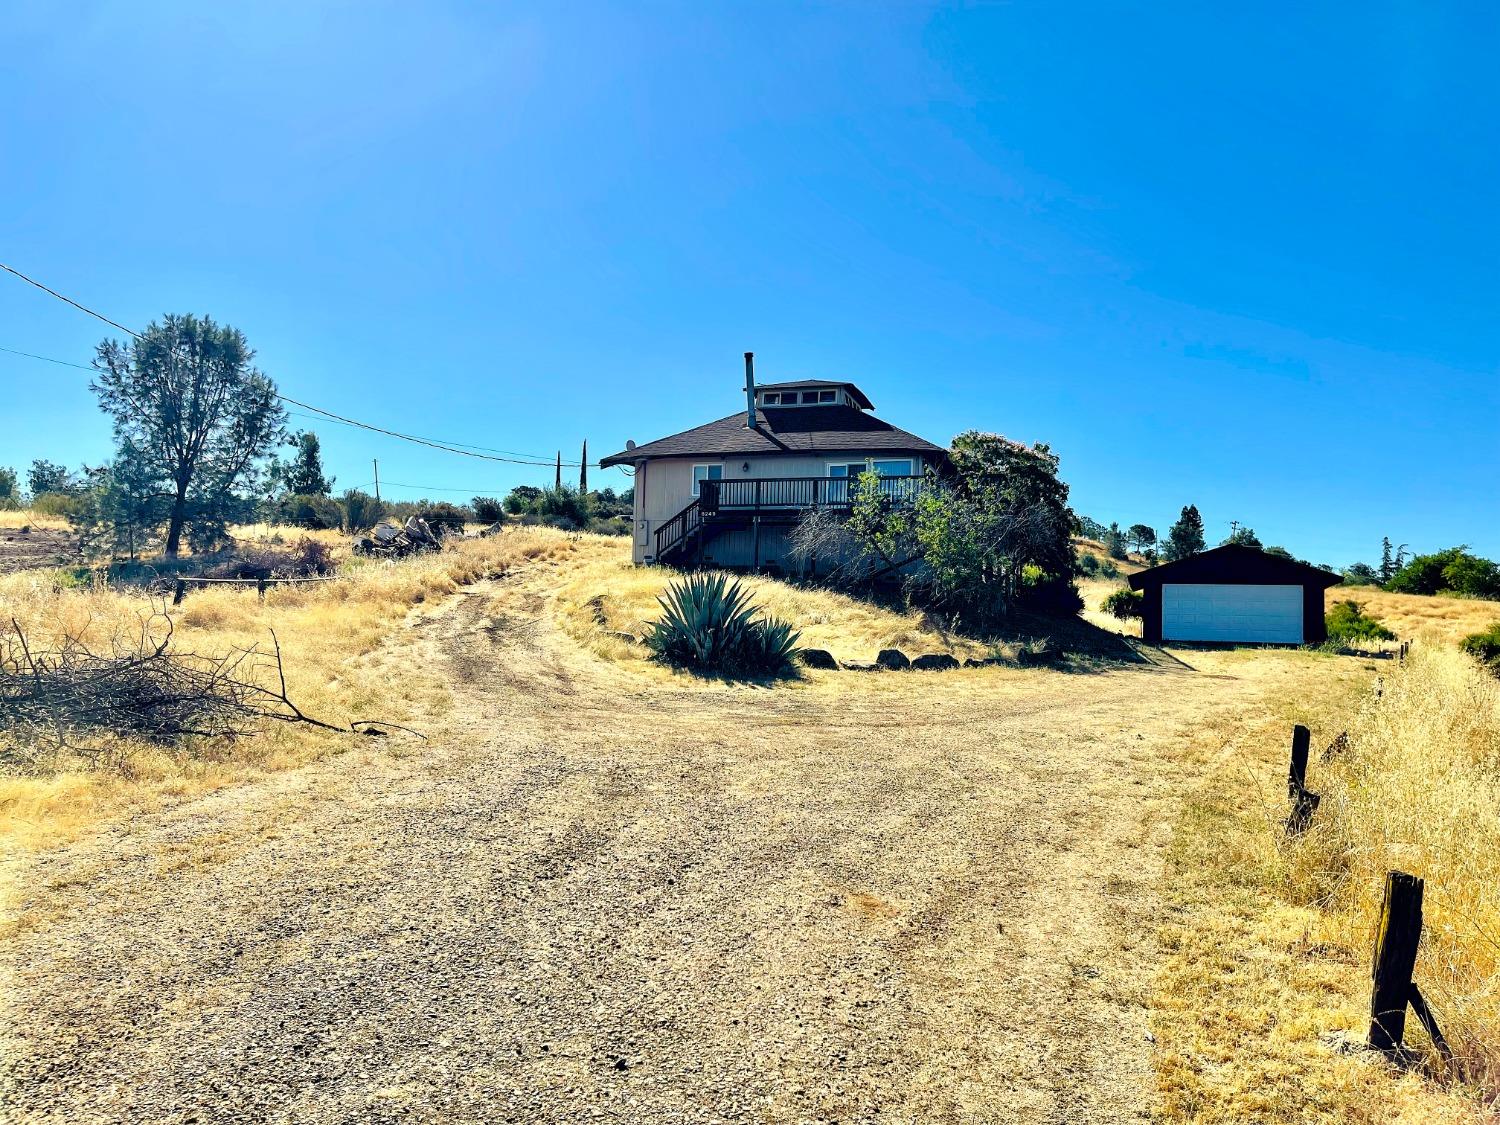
<box><xmin>0</xmin><ymin>528</ymin><xmax>584</xmax><ymax>848</ymax></box>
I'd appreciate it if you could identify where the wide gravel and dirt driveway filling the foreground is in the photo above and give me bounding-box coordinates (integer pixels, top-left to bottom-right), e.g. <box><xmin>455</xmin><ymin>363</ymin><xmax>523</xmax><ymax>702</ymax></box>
<box><xmin>0</xmin><ymin>582</ymin><xmax>1290</xmax><ymax>1122</ymax></box>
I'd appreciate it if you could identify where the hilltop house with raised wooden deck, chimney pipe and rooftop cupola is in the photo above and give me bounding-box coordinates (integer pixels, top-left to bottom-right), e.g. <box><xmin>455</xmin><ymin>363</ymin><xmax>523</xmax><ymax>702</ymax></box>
<box><xmin>599</xmin><ymin>353</ymin><xmax>948</xmax><ymax>572</ymax></box>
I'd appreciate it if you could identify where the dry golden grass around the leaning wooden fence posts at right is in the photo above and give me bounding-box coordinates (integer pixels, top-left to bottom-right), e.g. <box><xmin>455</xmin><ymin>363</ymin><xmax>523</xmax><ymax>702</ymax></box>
<box><xmin>1155</xmin><ymin>647</ymin><xmax>1500</xmax><ymax>1122</ymax></box>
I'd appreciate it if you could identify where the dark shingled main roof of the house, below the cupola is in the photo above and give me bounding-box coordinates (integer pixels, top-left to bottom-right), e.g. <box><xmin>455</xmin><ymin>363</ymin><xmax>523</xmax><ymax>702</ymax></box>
<box><xmin>599</xmin><ymin>408</ymin><xmax>947</xmax><ymax>468</ymax></box>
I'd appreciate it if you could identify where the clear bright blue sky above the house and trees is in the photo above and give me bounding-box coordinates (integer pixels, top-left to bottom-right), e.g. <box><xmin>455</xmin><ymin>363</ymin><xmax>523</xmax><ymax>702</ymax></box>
<box><xmin>0</xmin><ymin>0</ymin><xmax>1500</xmax><ymax>564</ymax></box>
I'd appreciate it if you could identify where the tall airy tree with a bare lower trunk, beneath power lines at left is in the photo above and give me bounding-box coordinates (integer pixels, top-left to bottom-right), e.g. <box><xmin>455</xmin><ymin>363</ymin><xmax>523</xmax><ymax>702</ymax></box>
<box><xmin>92</xmin><ymin>315</ymin><xmax>287</xmax><ymax>558</ymax></box>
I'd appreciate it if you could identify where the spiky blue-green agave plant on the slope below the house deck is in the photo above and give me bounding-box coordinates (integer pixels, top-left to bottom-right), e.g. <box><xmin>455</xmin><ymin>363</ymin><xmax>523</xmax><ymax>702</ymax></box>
<box><xmin>645</xmin><ymin>575</ymin><xmax>801</xmax><ymax>677</ymax></box>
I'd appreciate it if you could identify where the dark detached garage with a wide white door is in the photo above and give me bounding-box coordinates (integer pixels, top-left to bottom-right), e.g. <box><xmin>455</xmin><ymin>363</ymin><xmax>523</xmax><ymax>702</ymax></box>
<box><xmin>1130</xmin><ymin>545</ymin><xmax>1343</xmax><ymax>645</ymax></box>
